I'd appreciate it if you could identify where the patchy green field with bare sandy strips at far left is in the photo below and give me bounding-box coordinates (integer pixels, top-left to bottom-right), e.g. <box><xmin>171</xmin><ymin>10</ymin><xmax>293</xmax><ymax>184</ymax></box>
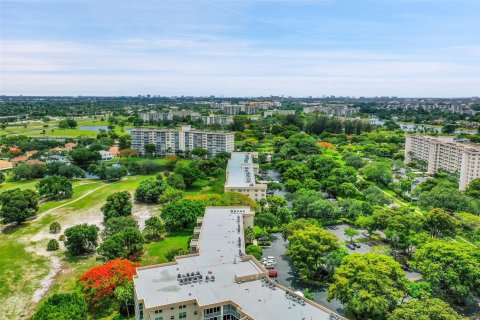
<box><xmin>0</xmin><ymin>176</ymin><xmax>158</xmax><ymax>319</ymax></box>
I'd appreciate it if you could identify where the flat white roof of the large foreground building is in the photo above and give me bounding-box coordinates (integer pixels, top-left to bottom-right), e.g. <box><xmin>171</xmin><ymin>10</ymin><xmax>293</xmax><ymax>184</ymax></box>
<box><xmin>134</xmin><ymin>207</ymin><xmax>338</xmax><ymax>320</ymax></box>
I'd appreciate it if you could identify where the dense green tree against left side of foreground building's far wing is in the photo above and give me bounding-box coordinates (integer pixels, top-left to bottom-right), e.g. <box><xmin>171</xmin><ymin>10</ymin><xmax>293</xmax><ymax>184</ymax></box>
<box><xmin>161</xmin><ymin>199</ymin><xmax>205</xmax><ymax>230</ymax></box>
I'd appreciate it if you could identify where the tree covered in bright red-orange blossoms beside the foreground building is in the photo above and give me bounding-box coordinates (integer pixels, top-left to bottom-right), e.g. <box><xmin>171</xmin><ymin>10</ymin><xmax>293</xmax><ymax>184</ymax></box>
<box><xmin>79</xmin><ymin>259</ymin><xmax>140</xmax><ymax>306</ymax></box>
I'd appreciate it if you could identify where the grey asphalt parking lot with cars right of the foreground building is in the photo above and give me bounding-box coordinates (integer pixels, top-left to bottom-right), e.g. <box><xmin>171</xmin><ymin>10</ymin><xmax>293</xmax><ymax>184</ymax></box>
<box><xmin>263</xmin><ymin>233</ymin><xmax>346</xmax><ymax>315</ymax></box>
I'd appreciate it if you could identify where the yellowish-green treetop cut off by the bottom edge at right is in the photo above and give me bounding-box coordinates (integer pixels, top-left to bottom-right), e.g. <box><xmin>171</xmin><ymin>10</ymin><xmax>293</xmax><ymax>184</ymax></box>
<box><xmin>388</xmin><ymin>298</ymin><xmax>465</xmax><ymax>320</ymax></box>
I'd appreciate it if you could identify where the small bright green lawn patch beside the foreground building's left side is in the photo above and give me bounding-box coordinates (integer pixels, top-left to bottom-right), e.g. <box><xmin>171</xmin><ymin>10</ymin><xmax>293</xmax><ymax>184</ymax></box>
<box><xmin>141</xmin><ymin>230</ymin><xmax>193</xmax><ymax>265</ymax></box>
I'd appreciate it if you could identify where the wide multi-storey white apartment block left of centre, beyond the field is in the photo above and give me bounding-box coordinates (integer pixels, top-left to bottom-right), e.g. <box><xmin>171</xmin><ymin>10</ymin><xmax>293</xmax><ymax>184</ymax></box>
<box><xmin>131</xmin><ymin>126</ymin><xmax>234</xmax><ymax>156</ymax></box>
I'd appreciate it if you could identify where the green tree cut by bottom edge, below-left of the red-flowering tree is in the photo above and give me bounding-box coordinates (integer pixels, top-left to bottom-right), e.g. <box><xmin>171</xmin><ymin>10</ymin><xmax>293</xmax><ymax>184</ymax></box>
<box><xmin>31</xmin><ymin>292</ymin><xmax>88</xmax><ymax>320</ymax></box>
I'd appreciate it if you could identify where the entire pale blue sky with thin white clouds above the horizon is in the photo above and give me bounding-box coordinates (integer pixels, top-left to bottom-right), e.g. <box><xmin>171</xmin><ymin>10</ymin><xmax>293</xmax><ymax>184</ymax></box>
<box><xmin>0</xmin><ymin>0</ymin><xmax>480</xmax><ymax>97</ymax></box>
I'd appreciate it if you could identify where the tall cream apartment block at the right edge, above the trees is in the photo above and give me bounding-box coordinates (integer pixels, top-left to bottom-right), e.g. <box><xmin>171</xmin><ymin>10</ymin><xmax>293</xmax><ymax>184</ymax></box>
<box><xmin>405</xmin><ymin>135</ymin><xmax>480</xmax><ymax>190</ymax></box>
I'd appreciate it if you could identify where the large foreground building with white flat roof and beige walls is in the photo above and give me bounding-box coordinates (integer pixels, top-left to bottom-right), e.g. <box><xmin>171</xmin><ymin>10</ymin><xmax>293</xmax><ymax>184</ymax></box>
<box><xmin>133</xmin><ymin>207</ymin><xmax>343</xmax><ymax>320</ymax></box>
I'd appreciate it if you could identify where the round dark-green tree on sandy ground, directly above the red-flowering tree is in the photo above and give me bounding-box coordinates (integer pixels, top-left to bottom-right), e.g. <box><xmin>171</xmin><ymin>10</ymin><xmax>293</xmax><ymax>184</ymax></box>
<box><xmin>65</xmin><ymin>223</ymin><xmax>98</xmax><ymax>255</ymax></box>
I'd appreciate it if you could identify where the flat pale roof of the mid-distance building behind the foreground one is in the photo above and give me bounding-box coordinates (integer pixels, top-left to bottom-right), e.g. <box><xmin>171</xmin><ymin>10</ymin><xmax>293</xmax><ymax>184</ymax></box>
<box><xmin>225</xmin><ymin>152</ymin><xmax>262</xmax><ymax>188</ymax></box>
